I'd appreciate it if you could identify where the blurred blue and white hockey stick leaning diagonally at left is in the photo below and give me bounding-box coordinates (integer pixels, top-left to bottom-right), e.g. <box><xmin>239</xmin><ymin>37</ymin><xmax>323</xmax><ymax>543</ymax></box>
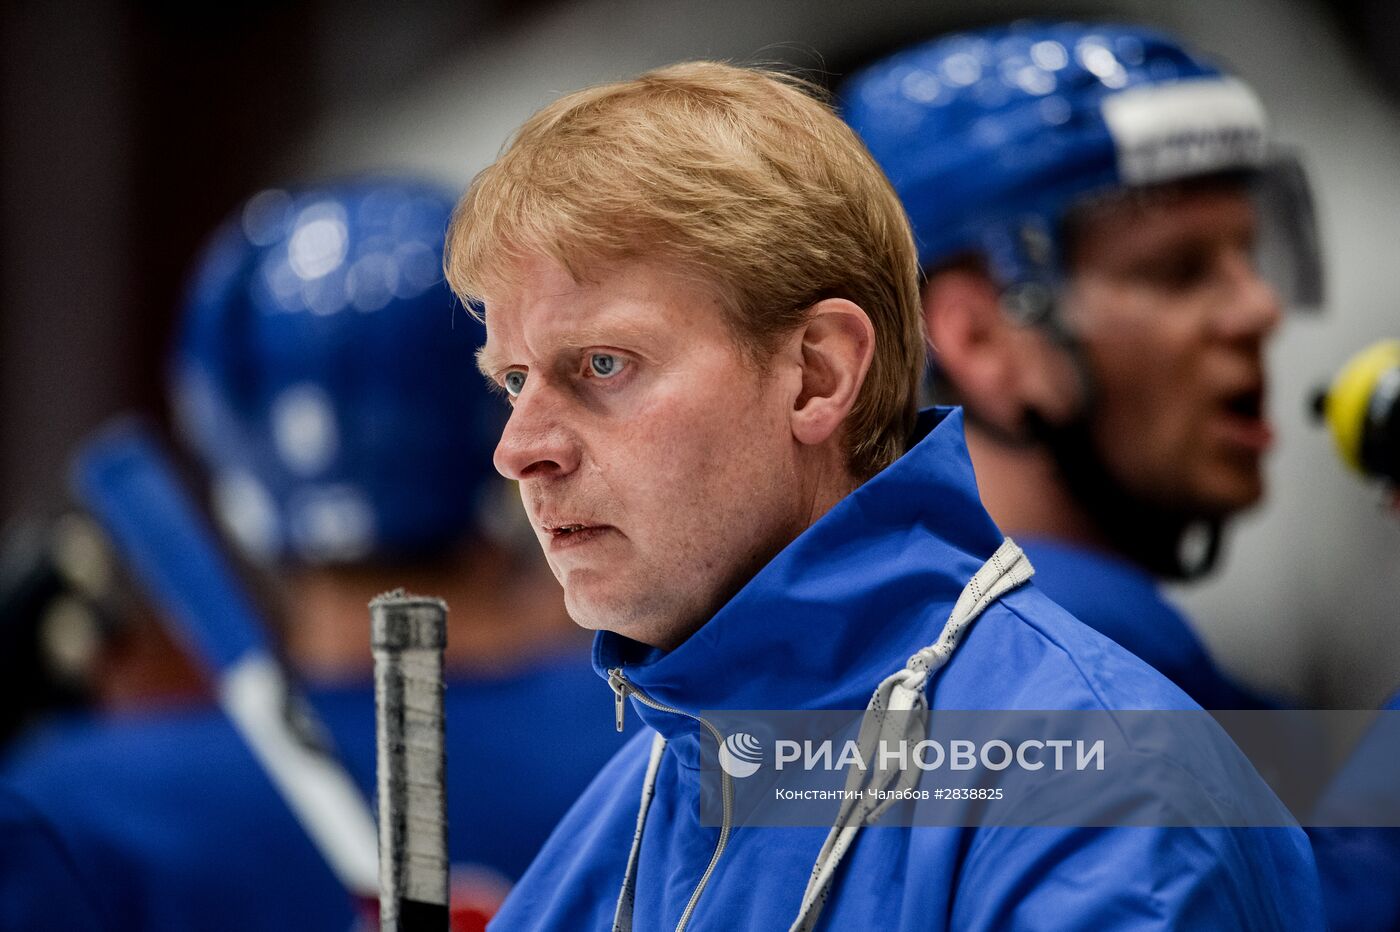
<box><xmin>73</xmin><ymin>420</ymin><xmax>378</xmax><ymax>903</ymax></box>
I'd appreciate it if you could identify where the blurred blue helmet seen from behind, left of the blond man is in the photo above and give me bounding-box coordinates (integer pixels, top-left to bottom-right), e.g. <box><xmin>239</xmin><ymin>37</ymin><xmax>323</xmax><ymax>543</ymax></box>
<box><xmin>172</xmin><ymin>179</ymin><xmax>504</xmax><ymax>563</ymax></box>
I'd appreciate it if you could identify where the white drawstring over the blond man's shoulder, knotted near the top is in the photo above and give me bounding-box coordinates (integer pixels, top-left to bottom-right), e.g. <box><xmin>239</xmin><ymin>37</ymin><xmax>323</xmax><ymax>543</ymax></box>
<box><xmin>790</xmin><ymin>537</ymin><xmax>1035</xmax><ymax>932</ymax></box>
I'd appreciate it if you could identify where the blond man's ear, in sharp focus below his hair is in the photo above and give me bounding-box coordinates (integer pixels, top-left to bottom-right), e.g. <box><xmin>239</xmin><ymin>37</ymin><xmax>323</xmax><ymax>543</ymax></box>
<box><xmin>792</xmin><ymin>298</ymin><xmax>875</xmax><ymax>445</ymax></box>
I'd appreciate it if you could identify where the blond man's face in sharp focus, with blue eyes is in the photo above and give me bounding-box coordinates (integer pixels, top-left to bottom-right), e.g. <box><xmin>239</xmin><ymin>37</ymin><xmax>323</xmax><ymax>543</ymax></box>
<box><xmin>482</xmin><ymin>259</ymin><xmax>804</xmax><ymax>648</ymax></box>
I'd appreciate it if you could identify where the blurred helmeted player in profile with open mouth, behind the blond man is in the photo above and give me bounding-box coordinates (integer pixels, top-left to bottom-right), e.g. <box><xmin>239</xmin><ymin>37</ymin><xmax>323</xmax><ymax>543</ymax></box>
<box><xmin>841</xmin><ymin>24</ymin><xmax>1400</xmax><ymax>928</ymax></box>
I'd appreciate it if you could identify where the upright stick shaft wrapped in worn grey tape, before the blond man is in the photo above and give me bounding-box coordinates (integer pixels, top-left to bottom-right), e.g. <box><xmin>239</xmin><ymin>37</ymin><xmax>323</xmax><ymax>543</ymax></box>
<box><xmin>370</xmin><ymin>591</ymin><xmax>448</xmax><ymax>932</ymax></box>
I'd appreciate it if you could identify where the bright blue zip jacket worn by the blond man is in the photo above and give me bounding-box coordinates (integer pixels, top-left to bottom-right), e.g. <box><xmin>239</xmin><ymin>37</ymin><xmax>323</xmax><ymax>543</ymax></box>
<box><xmin>491</xmin><ymin>411</ymin><xmax>1322</xmax><ymax>932</ymax></box>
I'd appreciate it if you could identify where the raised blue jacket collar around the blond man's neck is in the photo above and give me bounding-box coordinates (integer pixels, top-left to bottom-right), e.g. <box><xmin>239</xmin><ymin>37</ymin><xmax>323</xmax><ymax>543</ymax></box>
<box><xmin>594</xmin><ymin>409</ymin><xmax>1002</xmax><ymax>739</ymax></box>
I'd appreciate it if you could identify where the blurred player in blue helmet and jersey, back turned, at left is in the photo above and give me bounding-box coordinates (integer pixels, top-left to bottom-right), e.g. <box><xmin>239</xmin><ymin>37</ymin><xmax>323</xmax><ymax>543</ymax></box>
<box><xmin>7</xmin><ymin>179</ymin><xmax>615</xmax><ymax>929</ymax></box>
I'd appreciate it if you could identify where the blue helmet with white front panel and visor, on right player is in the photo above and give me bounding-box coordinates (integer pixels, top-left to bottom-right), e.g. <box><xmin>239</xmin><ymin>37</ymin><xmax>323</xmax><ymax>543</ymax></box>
<box><xmin>840</xmin><ymin>22</ymin><xmax>1320</xmax><ymax>319</ymax></box>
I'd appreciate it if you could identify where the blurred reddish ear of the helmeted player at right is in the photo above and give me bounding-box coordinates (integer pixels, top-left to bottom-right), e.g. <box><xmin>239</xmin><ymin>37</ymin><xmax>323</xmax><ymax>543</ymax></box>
<box><xmin>924</xmin><ymin>267</ymin><xmax>1065</xmax><ymax>435</ymax></box>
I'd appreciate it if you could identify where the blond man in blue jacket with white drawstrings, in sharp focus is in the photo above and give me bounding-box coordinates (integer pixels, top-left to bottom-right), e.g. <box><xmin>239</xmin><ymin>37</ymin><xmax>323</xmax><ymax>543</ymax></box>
<box><xmin>447</xmin><ymin>63</ymin><xmax>1317</xmax><ymax>929</ymax></box>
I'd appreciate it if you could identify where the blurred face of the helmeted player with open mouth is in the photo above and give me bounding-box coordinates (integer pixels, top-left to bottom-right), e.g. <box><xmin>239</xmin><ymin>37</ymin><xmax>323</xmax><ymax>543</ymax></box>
<box><xmin>1065</xmin><ymin>185</ymin><xmax>1280</xmax><ymax>516</ymax></box>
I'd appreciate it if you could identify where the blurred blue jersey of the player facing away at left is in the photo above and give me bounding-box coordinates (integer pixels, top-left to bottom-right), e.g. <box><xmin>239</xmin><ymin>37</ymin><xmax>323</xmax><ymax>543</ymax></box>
<box><xmin>0</xmin><ymin>656</ymin><xmax>620</xmax><ymax>932</ymax></box>
